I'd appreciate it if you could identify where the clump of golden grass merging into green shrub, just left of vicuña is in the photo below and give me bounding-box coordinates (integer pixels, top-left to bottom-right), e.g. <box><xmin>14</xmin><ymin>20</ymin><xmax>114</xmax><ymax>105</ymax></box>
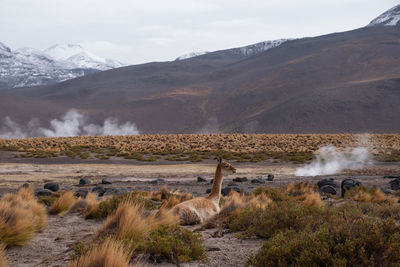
<box><xmin>95</xmin><ymin>202</ymin><xmax>206</xmax><ymax>263</ymax></box>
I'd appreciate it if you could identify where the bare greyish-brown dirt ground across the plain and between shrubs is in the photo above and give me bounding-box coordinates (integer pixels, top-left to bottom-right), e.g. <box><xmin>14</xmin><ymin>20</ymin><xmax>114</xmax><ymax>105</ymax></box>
<box><xmin>0</xmin><ymin>152</ymin><xmax>400</xmax><ymax>267</ymax></box>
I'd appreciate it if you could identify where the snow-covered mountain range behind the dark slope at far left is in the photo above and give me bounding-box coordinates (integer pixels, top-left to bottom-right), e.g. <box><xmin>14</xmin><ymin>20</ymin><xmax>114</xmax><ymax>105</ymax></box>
<box><xmin>0</xmin><ymin>43</ymin><xmax>123</xmax><ymax>89</ymax></box>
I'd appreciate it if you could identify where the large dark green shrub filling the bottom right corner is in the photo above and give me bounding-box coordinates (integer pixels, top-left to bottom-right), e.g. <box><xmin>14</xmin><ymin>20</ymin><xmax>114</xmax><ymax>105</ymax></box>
<box><xmin>248</xmin><ymin>216</ymin><xmax>400</xmax><ymax>266</ymax></box>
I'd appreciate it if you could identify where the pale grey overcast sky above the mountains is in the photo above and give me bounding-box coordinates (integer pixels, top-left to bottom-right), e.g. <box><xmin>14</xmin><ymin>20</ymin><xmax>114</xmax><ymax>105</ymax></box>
<box><xmin>0</xmin><ymin>0</ymin><xmax>400</xmax><ymax>64</ymax></box>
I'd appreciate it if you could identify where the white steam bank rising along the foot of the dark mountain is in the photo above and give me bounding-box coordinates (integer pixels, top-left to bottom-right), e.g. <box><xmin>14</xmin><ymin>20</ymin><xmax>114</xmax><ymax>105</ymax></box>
<box><xmin>0</xmin><ymin>110</ymin><xmax>139</xmax><ymax>138</ymax></box>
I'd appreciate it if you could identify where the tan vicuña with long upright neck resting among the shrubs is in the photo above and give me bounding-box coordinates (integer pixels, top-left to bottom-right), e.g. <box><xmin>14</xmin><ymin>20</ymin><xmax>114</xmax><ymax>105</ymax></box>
<box><xmin>172</xmin><ymin>158</ymin><xmax>236</xmax><ymax>224</ymax></box>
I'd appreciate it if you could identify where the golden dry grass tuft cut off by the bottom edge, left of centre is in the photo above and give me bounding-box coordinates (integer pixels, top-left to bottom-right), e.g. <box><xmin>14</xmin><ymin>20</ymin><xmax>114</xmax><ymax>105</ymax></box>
<box><xmin>69</xmin><ymin>239</ymin><xmax>131</xmax><ymax>267</ymax></box>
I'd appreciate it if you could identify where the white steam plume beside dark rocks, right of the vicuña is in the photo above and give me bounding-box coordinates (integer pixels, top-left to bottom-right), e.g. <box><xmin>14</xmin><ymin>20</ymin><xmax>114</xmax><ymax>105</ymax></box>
<box><xmin>295</xmin><ymin>145</ymin><xmax>371</xmax><ymax>176</ymax></box>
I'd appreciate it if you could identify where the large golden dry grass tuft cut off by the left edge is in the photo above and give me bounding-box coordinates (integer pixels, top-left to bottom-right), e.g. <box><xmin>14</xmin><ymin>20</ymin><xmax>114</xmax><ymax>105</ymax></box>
<box><xmin>0</xmin><ymin>187</ymin><xmax>47</xmax><ymax>246</ymax></box>
